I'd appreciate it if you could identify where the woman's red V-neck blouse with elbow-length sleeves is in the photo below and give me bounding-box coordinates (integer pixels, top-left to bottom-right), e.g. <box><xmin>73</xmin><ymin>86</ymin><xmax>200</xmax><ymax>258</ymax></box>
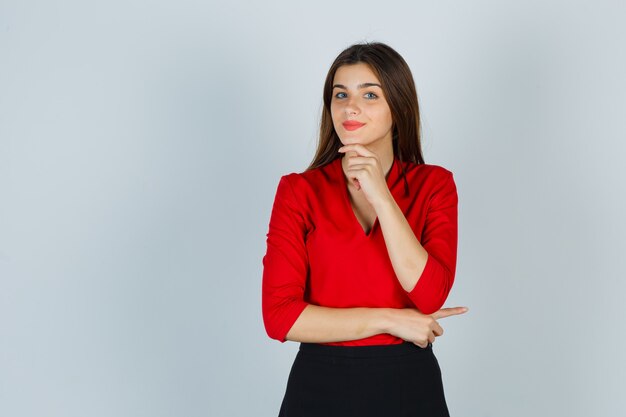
<box><xmin>262</xmin><ymin>155</ymin><xmax>458</xmax><ymax>346</ymax></box>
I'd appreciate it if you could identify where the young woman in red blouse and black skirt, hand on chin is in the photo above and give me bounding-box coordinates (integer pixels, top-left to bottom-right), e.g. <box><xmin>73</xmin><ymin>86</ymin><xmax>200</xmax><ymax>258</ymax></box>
<box><xmin>262</xmin><ymin>43</ymin><xmax>467</xmax><ymax>417</ymax></box>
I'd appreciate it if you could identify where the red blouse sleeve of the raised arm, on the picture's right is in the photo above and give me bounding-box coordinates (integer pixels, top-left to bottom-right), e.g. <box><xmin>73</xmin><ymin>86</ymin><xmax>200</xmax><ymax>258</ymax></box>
<box><xmin>408</xmin><ymin>171</ymin><xmax>458</xmax><ymax>314</ymax></box>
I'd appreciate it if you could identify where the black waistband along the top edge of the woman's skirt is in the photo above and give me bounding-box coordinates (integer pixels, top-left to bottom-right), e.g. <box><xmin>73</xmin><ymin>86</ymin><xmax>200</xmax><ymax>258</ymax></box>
<box><xmin>300</xmin><ymin>342</ymin><xmax>433</xmax><ymax>358</ymax></box>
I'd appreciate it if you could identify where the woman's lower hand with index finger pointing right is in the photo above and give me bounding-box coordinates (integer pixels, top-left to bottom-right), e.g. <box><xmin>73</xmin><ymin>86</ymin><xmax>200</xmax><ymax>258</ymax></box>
<box><xmin>388</xmin><ymin>307</ymin><xmax>468</xmax><ymax>348</ymax></box>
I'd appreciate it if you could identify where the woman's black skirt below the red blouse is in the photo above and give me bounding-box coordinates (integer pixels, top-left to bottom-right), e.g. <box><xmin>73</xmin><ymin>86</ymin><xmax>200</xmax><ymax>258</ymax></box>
<box><xmin>279</xmin><ymin>342</ymin><xmax>450</xmax><ymax>417</ymax></box>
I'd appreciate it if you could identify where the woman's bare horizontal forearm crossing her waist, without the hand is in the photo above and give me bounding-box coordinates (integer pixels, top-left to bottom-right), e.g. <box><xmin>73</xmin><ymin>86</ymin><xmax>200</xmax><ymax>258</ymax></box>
<box><xmin>286</xmin><ymin>304</ymin><xmax>391</xmax><ymax>343</ymax></box>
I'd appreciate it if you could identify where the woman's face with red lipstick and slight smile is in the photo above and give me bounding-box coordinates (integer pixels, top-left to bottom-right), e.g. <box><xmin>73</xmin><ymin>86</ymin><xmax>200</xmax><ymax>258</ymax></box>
<box><xmin>330</xmin><ymin>63</ymin><xmax>393</xmax><ymax>151</ymax></box>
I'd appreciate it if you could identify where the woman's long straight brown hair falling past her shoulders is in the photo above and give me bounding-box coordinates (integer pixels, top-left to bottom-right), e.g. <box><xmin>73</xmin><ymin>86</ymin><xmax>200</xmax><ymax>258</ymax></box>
<box><xmin>307</xmin><ymin>42</ymin><xmax>424</xmax><ymax>192</ymax></box>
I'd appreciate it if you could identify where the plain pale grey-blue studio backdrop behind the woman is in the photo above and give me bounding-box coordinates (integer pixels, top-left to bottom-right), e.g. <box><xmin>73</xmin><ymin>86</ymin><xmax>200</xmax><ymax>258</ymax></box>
<box><xmin>0</xmin><ymin>0</ymin><xmax>626</xmax><ymax>417</ymax></box>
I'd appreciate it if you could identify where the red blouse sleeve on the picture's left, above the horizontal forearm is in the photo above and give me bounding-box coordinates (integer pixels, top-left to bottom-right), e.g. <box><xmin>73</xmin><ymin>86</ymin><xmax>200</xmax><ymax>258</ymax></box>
<box><xmin>261</xmin><ymin>175</ymin><xmax>309</xmax><ymax>343</ymax></box>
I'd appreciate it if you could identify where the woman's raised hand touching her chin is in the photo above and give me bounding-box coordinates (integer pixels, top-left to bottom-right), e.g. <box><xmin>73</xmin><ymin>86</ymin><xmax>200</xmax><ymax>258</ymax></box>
<box><xmin>339</xmin><ymin>144</ymin><xmax>393</xmax><ymax>207</ymax></box>
